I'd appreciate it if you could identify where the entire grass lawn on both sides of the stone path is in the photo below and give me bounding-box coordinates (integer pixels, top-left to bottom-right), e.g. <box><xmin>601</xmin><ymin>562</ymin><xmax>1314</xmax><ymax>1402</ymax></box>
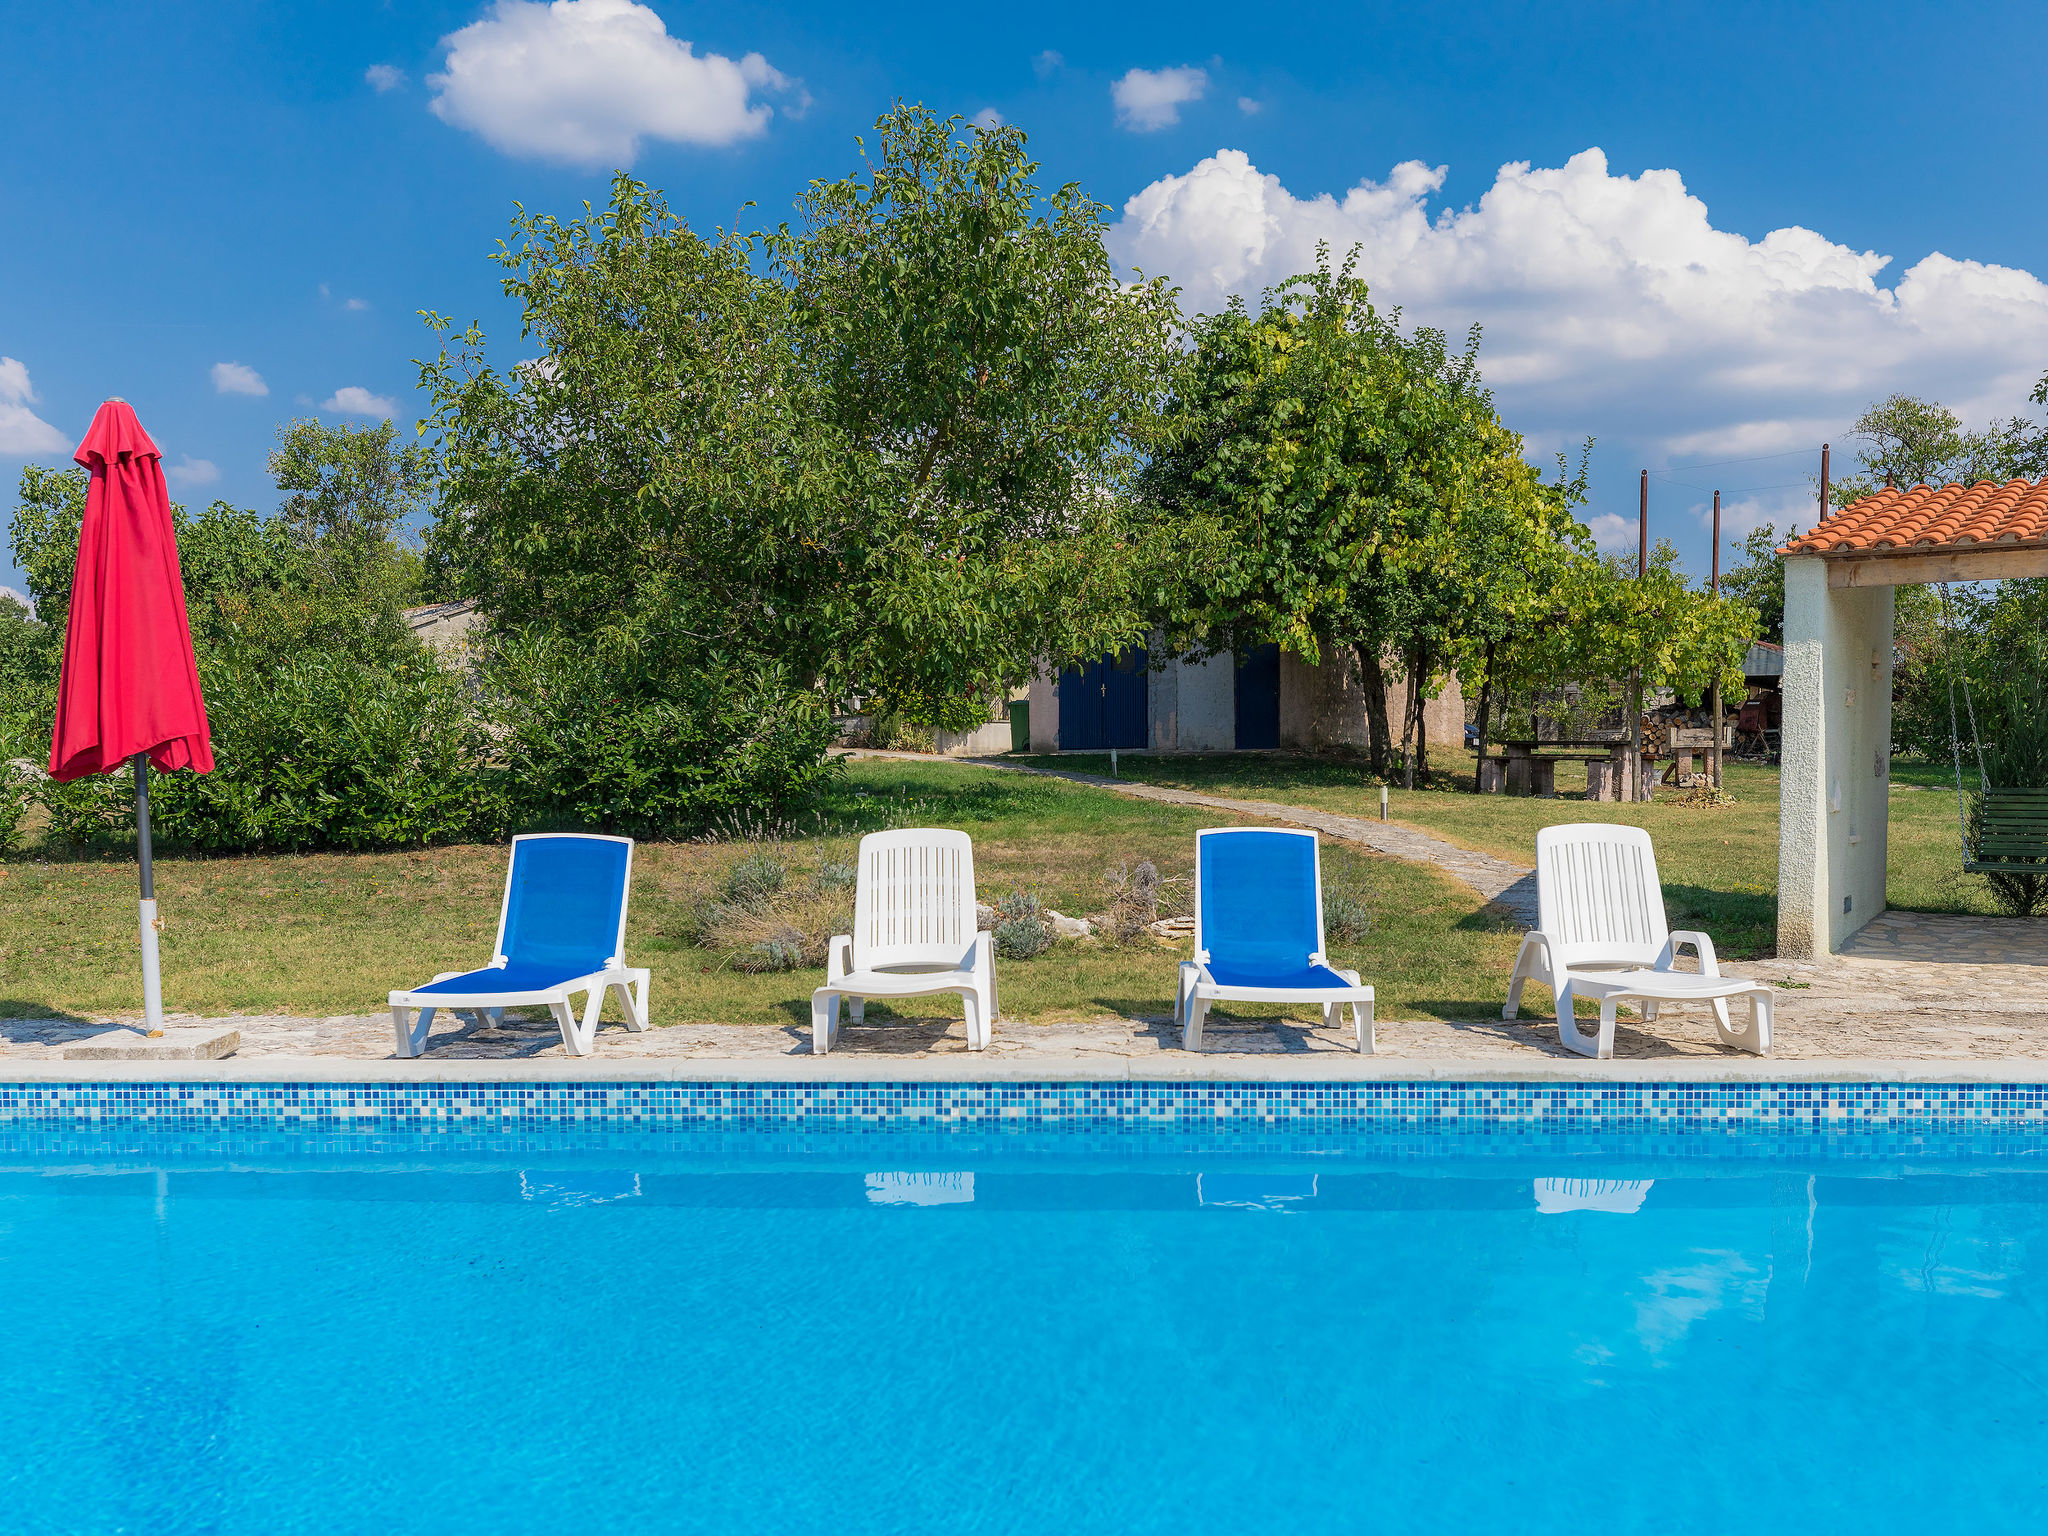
<box><xmin>0</xmin><ymin>756</ymin><xmax>1991</xmax><ymax>1024</ymax></box>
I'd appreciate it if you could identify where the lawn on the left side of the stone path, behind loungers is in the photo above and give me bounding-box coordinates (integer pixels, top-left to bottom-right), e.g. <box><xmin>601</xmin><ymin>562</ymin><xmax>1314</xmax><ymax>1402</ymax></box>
<box><xmin>0</xmin><ymin>762</ymin><xmax>1516</xmax><ymax>1024</ymax></box>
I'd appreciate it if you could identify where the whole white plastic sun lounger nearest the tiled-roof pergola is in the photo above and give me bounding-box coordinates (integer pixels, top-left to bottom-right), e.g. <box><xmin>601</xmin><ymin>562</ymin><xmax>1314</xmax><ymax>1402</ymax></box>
<box><xmin>1501</xmin><ymin>823</ymin><xmax>1772</xmax><ymax>1057</ymax></box>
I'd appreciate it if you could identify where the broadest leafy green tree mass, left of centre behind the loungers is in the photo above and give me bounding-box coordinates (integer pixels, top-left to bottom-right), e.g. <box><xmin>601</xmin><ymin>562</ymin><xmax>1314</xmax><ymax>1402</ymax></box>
<box><xmin>422</xmin><ymin>106</ymin><xmax>1178</xmax><ymax>831</ymax></box>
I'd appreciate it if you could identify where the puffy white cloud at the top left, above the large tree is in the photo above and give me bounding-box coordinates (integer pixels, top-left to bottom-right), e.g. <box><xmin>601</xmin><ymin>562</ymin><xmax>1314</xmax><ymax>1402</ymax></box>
<box><xmin>426</xmin><ymin>0</ymin><xmax>791</xmax><ymax>170</ymax></box>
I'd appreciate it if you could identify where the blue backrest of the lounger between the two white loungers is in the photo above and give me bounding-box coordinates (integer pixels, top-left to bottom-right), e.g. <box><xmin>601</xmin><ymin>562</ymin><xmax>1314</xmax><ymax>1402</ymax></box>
<box><xmin>1194</xmin><ymin>827</ymin><xmax>1323</xmax><ymax>969</ymax></box>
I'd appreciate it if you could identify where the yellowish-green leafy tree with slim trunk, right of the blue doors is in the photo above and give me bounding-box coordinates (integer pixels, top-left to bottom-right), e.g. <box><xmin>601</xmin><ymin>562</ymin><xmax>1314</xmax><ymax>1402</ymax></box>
<box><xmin>1145</xmin><ymin>254</ymin><xmax>1501</xmax><ymax>772</ymax></box>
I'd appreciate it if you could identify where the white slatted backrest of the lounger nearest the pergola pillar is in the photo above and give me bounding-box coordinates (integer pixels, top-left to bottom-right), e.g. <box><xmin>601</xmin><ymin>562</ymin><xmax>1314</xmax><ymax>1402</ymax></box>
<box><xmin>1536</xmin><ymin>821</ymin><xmax>1671</xmax><ymax>965</ymax></box>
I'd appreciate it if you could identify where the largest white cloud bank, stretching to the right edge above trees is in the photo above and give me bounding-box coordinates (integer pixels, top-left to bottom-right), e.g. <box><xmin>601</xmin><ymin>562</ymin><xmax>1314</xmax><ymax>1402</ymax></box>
<box><xmin>1110</xmin><ymin>150</ymin><xmax>2048</xmax><ymax>507</ymax></box>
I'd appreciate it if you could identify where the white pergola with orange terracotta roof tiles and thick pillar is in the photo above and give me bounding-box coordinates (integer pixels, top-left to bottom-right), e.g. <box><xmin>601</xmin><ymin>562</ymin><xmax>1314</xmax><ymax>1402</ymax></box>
<box><xmin>1778</xmin><ymin>479</ymin><xmax>2048</xmax><ymax>958</ymax></box>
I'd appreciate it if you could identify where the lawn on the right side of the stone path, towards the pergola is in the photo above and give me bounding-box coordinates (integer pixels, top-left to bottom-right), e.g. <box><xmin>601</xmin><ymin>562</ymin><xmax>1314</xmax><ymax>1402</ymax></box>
<box><xmin>1018</xmin><ymin>752</ymin><xmax>1997</xmax><ymax>956</ymax></box>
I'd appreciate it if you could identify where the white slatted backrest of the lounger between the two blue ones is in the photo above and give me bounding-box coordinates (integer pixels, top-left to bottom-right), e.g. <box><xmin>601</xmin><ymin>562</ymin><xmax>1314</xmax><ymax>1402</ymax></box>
<box><xmin>854</xmin><ymin>827</ymin><xmax>975</xmax><ymax>971</ymax></box>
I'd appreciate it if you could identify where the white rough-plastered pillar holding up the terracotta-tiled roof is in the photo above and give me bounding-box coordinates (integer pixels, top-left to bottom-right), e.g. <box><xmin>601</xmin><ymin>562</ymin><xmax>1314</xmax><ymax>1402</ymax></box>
<box><xmin>1778</xmin><ymin>555</ymin><xmax>1892</xmax><ymax>958</ymax></box>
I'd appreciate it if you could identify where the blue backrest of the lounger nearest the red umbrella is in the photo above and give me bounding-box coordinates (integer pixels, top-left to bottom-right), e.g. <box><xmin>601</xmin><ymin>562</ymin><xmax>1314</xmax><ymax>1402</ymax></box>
<box><xmin>498</xmin><ymin>831</ymin><xmax>633</xmax><ymax>975</ymax></box>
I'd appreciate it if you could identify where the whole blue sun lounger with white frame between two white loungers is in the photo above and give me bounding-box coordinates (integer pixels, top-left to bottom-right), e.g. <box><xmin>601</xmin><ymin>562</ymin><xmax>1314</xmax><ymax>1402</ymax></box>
<box><xmin>1174</xmin><ymin>827</ymin><xmax>1372</xmax><ymax>1051</ymax></box>
